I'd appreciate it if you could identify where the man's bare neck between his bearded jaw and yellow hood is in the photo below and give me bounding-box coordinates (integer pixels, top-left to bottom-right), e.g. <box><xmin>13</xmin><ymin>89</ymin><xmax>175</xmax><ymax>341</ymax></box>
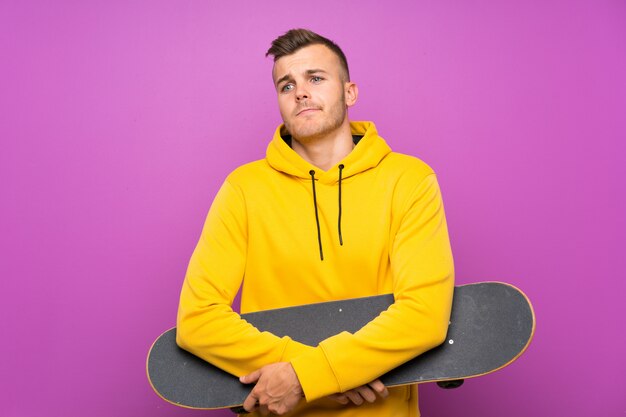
<box><xmin>291</xmin><ymin>120</ymin><xmax>354</xmax><ymax>171</ymax></box>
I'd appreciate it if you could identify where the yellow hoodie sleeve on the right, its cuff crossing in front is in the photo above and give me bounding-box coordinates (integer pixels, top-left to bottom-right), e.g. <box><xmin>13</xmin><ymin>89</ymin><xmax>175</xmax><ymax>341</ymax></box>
<box><xmin>291</xmin><ymin>174</ymin><xmax>454</xmax><ymax>401</ymax></box>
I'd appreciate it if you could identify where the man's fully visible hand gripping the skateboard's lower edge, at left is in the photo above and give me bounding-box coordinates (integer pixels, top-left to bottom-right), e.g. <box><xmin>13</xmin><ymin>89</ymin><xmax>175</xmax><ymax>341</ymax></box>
<box><xmin>239</xmin><ymin>362</ymin><xmax>304</xmax><ymax>416</ymax></box>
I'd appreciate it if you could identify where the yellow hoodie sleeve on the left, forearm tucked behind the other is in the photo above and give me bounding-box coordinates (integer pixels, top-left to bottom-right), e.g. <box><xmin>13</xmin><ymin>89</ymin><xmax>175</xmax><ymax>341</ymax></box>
<box><xmin>176</xmin><ymin>180</ymin><xmax>312</xmax><ymax>376</ymax></box>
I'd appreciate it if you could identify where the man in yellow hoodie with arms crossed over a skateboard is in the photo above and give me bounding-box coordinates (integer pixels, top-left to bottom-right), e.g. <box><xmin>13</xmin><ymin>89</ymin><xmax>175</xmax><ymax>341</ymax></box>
<box><xmin>178</xmin><ymin>29</ymin><xmax>454</xmax><ymax>417</ymax></box>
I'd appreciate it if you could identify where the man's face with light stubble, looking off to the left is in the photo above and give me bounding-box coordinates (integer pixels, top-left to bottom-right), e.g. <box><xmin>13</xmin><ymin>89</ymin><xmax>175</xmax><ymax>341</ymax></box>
<box><xmin>272</xmin><ymin>45</ymin><xmax>357</xmax><ymax>143</ymax></box>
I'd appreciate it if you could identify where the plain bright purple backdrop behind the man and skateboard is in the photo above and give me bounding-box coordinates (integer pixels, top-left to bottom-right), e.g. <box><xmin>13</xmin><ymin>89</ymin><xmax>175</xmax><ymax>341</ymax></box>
<box><xmin>0</xmin><ymin>0</ymin><xmax>626</xmax><ymax>417</ymax></box>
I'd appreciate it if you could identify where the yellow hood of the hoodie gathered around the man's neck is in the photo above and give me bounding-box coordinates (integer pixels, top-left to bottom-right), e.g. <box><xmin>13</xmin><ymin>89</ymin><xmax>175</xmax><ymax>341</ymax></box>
<box><xmin>266</xmin><ymin>122</ymin><xmax>391</xmax><ymax>185</ymax></box>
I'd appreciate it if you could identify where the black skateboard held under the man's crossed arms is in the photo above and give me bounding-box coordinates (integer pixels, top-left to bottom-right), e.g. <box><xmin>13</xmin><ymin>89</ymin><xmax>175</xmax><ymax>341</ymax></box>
<box><xmin>146</xmin><ymin>282</ymin><xmax>535</xmax><ymax>411</ymax></box>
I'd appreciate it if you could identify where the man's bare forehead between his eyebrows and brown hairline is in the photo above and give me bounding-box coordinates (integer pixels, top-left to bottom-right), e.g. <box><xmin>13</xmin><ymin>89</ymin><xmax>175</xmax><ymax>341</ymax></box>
<box><xmin>272</xmin><ymin>45</ymin><xmax>341</xmax><ymax>81</ymax></box>
